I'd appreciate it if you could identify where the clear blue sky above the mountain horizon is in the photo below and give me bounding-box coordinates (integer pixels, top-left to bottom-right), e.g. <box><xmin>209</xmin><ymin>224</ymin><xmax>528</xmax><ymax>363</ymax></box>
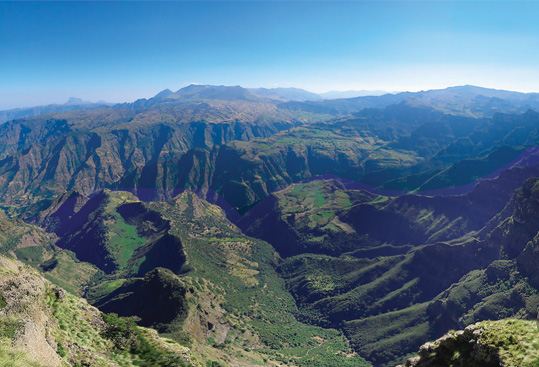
<box><xmin>0</xmin><ymin>1</ymin><xmax>539</xmax><ymax>109</ymax></box>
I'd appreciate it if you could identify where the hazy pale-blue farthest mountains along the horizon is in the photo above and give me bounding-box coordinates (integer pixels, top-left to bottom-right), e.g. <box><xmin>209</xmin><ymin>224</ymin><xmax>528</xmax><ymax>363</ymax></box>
<box><xmin>5</xmin><ymin>84</ymin><xmax>538</xmax><ymax>123</ymax></box>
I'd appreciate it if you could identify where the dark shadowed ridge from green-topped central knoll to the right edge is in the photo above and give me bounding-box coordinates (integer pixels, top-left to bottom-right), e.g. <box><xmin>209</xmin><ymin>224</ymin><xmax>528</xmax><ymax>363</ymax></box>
<box><xmin>237</xmin><ymin>165</ymin><xmax>539</xmax><ymax>258</ymax></box>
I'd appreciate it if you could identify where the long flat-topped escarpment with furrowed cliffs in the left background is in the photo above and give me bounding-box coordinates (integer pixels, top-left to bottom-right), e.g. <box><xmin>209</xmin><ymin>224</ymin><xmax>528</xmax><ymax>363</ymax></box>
<box><xmin>0</xmin><ymin>87</ymin><xmax>322</xmax><ymax>204</ymax></box>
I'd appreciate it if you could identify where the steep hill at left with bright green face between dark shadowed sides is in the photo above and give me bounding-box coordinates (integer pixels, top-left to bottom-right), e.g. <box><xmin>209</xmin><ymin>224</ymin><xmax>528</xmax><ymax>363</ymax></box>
<box><xmin>28</xmin><ymin>190</ymin><xmax>185</xmax><ymax>277</ymax></box>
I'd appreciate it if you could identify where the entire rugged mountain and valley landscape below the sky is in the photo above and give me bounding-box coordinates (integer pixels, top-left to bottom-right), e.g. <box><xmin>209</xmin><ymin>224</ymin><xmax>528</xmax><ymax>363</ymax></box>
<box><xmin>0</xmin><ymin>85</ymin><xmax>539</xmax><ymax>367</ymax></box>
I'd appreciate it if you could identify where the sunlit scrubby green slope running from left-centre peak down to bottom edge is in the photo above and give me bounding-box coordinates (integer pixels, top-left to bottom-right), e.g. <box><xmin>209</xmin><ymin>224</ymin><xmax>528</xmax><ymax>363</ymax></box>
<box><xmin>151</xmin><ymin>193</ymin><xmax>368</xmax><ymax>367</ymax></box>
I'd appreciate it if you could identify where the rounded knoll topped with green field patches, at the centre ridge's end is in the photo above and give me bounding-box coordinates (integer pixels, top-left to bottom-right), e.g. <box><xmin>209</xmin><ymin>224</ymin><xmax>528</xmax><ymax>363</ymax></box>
<box><xmin>238</xmin><ymin>179</ymin><xmax>380</xmax><ymax>257</ymax></box>
